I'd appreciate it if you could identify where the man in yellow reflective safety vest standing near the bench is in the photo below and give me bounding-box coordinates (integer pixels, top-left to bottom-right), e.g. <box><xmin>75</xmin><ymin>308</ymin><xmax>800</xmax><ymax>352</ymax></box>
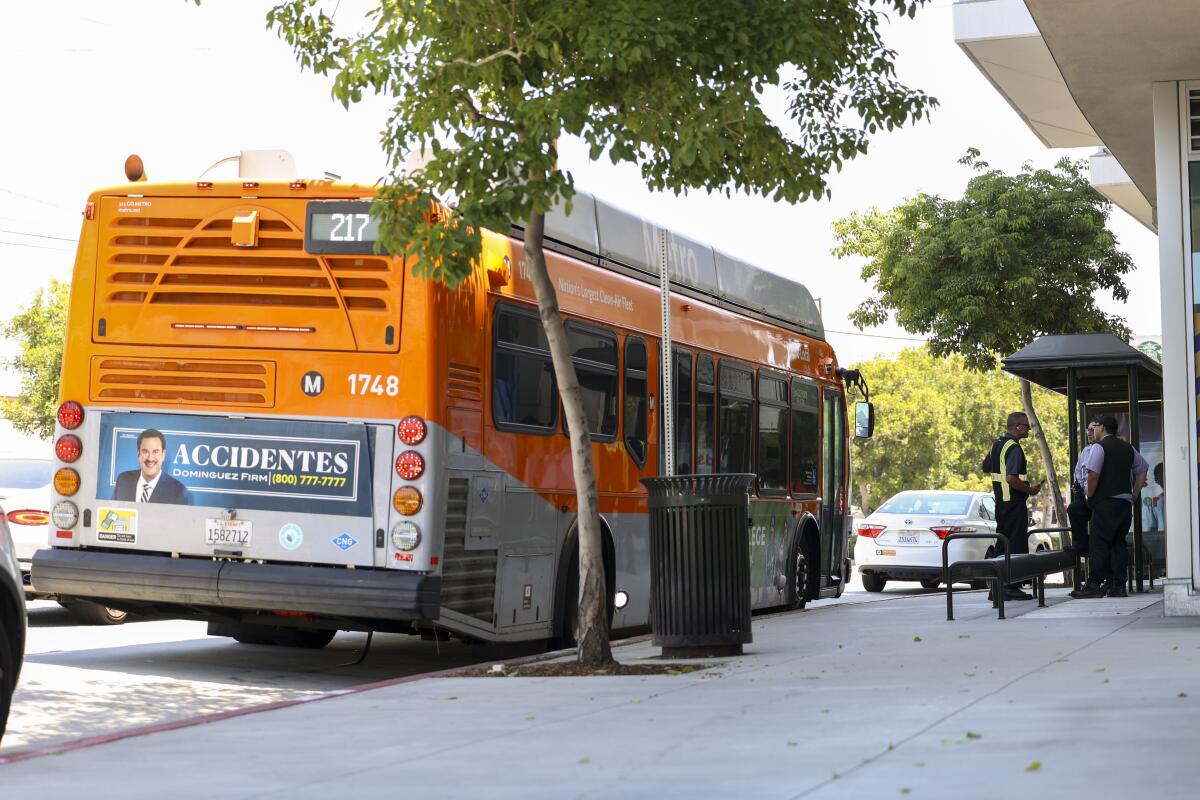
<box><xmin>983</xmin><ymin>411</ymin><xmax>1044</xmax><ymax>600</ymax></box>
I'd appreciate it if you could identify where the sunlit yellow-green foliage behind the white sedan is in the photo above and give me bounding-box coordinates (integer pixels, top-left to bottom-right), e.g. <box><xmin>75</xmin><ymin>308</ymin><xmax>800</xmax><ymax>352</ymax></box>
<box><xmin>851</xmin><ymin>348</ymin><xmax>1068</xmax><ymax>513</ymax></box>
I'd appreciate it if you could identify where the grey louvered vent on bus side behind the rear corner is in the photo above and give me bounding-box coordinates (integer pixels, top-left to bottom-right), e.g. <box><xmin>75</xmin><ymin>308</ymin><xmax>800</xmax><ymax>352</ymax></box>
<box><xmin>442</xmin><ymin>477</ymin><xmax>496</xmax><ymax>625</ymax></box>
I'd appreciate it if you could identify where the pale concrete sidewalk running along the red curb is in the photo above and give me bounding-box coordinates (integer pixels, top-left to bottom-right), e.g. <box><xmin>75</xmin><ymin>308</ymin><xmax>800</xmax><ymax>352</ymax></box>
<box><xmin>0</xmin><ymin>590</ymin><xmax>1200</xmax><ymax>800</ymax></box>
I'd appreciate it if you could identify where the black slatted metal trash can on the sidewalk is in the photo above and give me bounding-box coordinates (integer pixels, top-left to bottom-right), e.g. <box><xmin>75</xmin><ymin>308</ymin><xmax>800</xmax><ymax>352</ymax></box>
<box><xmin>642</xmin><ymin>474</ymin><xmax>755</xmax><ymax>657</ymax></box>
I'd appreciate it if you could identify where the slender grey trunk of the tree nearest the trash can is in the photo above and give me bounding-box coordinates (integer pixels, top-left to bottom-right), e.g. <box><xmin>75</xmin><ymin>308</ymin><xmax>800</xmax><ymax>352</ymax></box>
<box><xmin>524</xmin><ymin>212</ymin><xmax>613</xmax><ymax>667</ymax></box>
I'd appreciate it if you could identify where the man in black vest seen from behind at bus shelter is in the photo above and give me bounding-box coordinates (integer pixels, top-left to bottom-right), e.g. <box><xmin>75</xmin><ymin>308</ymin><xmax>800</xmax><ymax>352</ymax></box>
<box><xmin>1070</xmin><ymin>414</ymin><xmax>1150</xmax><ymax>597</ymax></box>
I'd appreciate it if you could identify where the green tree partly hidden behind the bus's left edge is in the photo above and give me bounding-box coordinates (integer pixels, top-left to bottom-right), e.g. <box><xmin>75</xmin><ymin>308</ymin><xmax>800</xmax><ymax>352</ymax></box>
<box><xmin>2</xmin><ymin>281</ymin><xmax>71</xmax><ymax>439</ymax></box>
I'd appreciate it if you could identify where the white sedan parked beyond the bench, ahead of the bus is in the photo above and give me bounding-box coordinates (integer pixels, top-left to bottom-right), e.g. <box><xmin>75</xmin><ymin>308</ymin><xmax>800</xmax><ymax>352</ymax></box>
<box><xmin>854</xmin><ymin>491</ymin><xmax>1054</xmax><ymax>591</ymax></box>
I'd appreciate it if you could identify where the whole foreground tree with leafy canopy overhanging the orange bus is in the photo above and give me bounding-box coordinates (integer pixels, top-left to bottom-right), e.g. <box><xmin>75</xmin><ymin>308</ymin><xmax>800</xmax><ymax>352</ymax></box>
<box><xmin>268</xmin><ymin>0</ymin><xmax>934</xmax><ymax>664</ymax></box>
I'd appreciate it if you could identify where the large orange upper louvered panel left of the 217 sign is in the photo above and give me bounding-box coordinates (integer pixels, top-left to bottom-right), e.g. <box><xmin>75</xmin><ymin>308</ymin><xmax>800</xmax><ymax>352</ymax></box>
<box><xmin>96</xmin><ymin>198</ymin><xmax>403</xmax><ymax>351</ymax></box>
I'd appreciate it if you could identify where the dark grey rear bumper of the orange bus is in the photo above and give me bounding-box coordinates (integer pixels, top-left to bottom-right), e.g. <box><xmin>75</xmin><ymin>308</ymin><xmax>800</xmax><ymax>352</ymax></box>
<box><xmin>34</xmin><ymin>548</ymin><xmax>442</xmax><ymax>620</ymax></box>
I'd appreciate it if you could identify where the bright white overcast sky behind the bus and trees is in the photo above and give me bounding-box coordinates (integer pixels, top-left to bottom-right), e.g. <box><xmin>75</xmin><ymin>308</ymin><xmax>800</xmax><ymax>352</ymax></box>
<box><xmin>0</xmin><ymin>0</ymin><xmax>1159</xmax><ymax>393</ymax></box>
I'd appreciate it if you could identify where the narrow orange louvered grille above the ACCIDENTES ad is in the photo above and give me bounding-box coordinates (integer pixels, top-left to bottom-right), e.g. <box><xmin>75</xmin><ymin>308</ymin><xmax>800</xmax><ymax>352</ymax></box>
<box><xmin>91</xmin><ymin>356</ymin><xmax>275</xmax><ymax>408</ymax></box>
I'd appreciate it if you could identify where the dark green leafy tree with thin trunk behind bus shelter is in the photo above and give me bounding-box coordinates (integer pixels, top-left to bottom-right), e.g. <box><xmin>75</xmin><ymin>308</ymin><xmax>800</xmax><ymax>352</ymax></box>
<box><xmin>834</xmin><ymin>149</ymin><xmax>1133</xmax><ymax>524</ymax></box>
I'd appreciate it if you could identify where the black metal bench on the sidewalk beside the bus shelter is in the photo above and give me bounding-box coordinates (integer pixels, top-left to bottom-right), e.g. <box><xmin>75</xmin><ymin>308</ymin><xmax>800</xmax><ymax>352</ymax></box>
<box><xmin>942</xmin><ymin>528</ymin><xmax>1079</xmax><ymax>620</ymax></box>
